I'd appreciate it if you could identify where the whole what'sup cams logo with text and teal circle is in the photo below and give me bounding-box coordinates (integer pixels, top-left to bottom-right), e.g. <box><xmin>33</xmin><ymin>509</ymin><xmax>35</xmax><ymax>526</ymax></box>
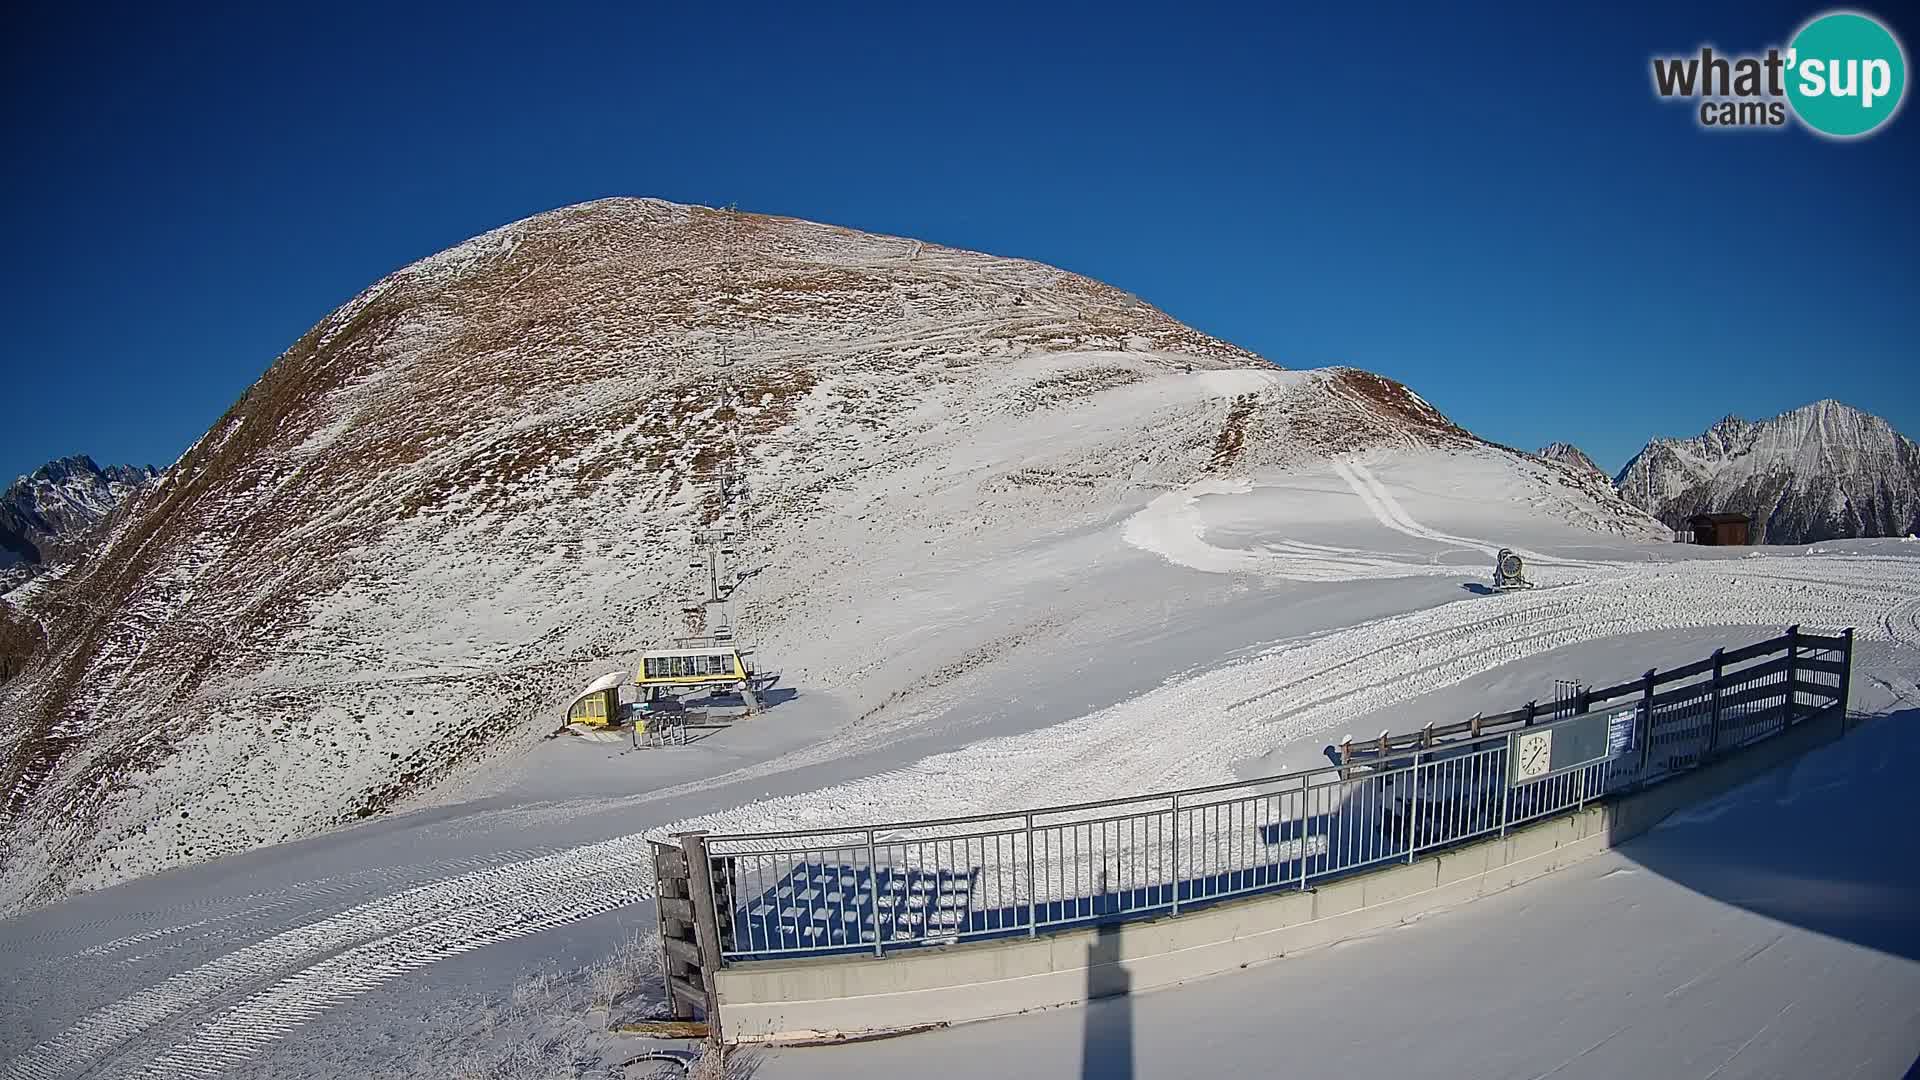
<box><xmin>1653</xmin><ymin>12</ymin><xmax>1907</xmax><ymax>138</ymax></box>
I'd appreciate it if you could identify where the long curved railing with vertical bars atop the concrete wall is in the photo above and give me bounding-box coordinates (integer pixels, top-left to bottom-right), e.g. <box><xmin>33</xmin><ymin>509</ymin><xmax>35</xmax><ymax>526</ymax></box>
<box><xmin>668</xmin><ymin>626</ymin><xmax>1853</xmax><ymax>965</ymax></box>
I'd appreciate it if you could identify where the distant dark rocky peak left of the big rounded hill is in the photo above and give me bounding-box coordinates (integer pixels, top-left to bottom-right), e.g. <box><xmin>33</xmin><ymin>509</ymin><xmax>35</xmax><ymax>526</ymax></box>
<box><xmin>0</xmin><ymin>454</ymin><xmax>159</xmax><ymax>584</ymax></box>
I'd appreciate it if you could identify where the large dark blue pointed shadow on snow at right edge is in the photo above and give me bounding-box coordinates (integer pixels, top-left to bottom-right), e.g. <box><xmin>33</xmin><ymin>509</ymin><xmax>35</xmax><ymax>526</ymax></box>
<box><xmin>1619</xmin><ymin>709</ymin><xmax>1920</xmax><ymax>961</ymax></box>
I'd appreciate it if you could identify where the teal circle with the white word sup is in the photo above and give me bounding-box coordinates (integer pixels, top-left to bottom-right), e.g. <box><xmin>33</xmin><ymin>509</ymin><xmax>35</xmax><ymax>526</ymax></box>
<box><xmin>1788</xmin><ymin>12</ymin><xmax>1907</xmax><ymax>138</ymax></box>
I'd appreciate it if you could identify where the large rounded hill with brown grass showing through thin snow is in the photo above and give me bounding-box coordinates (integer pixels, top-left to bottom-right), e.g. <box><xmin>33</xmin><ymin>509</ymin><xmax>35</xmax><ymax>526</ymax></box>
<box><xmin>0</xmin><ymin>200</ymin><xmax>1649</xmax><ymax>905</ymax></box>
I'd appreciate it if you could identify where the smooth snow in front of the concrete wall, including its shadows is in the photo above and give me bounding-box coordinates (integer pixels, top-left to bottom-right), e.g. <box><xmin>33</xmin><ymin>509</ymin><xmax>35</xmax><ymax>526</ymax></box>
<box><xmin>760</xmin><ymin>707</ymin><xmax>1920</xmax><ymax>1080</ymax></box>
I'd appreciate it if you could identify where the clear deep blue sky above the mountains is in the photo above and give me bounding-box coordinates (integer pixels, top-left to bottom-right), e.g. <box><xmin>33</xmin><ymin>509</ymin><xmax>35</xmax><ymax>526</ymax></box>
<box><xmin>0</xmin><ymin>4</ymin><xmax>1920</xmax><ymax>475</ymax></box>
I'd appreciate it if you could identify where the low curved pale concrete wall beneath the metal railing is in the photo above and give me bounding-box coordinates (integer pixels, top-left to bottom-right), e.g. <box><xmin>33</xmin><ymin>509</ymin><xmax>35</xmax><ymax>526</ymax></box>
<box><xmin>716</xmin><ymin>711</ymin><xmax>1841</xmax><ymax>1042</ymax></box>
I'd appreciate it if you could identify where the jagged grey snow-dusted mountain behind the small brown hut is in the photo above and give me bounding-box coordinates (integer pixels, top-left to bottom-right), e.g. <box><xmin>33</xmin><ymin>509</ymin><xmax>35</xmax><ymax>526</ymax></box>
<box><xmin>1617</xmin><ymin>400</ymin><xmax>1920</xmax><ymax>544</ymax></box>
